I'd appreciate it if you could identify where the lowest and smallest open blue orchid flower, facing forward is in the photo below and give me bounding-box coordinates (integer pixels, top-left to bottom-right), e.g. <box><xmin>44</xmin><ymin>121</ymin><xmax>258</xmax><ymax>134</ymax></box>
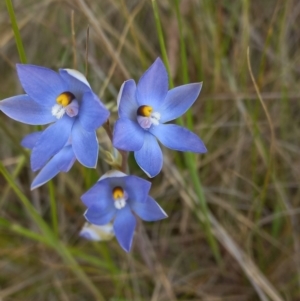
<box><xmin>81</xmin><ymin>170</ymin><xmax>167</xmax><ymax>252</ymax></box>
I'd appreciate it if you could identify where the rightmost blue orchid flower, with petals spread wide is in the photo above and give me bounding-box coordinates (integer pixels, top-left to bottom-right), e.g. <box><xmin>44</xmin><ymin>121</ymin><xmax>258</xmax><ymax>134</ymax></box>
<box><xmin>113</xmin><ymin>58</ymin><xmax>207</xmax><ymax>177</ymax></box>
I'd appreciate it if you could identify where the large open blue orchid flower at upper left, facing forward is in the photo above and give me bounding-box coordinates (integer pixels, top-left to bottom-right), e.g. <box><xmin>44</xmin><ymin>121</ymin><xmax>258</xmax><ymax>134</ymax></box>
<box><xmin>0</xmin><ymin>64</ymin><xmax>109</xmax><ymax>171</ymax></box>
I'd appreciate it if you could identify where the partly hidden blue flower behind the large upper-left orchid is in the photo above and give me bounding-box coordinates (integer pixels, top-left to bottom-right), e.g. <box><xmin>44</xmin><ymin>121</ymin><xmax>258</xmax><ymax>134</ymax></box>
<box><xmin>21</xmin><ymin>132</ymin><xmax>76</xmax><ymax>190</ymax></box>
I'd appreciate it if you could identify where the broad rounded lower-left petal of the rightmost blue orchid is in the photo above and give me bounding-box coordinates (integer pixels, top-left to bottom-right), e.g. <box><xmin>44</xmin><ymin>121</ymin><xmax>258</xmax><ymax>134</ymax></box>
<box><xmin>113</xmin><ymin>118</ymin><xmax>145</xmax><ymax>151</ymax></box>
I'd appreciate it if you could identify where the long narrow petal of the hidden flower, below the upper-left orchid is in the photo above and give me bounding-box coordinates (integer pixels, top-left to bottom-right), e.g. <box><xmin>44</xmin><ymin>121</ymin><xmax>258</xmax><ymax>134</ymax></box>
<box><xmin>31</xmin><ymin>146</ymin><xmax>74</xmax><ymax>190</ymax></box>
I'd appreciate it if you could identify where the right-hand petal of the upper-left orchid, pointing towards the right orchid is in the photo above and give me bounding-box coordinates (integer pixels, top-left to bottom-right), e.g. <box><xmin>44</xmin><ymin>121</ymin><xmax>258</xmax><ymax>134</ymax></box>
<box><xmin>79</xmin><ymin>91</ymin><xmax>109</xmax><ymax>132</ymax></box>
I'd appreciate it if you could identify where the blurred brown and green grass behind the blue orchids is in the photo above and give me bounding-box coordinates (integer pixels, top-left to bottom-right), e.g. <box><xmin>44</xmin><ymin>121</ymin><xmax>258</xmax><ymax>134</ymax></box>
<box><xmin>0</xmin><ymin>0</ymin><xmax>300</xmax><ymax>301</ymax></box>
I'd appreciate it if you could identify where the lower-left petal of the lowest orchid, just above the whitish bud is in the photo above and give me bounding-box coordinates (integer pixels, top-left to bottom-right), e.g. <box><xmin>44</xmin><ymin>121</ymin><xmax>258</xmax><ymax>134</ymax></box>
<box><xmin>84</xmin><ymin>205</ymin><xmax>117</xmax><ymax>226</ymax></box>
